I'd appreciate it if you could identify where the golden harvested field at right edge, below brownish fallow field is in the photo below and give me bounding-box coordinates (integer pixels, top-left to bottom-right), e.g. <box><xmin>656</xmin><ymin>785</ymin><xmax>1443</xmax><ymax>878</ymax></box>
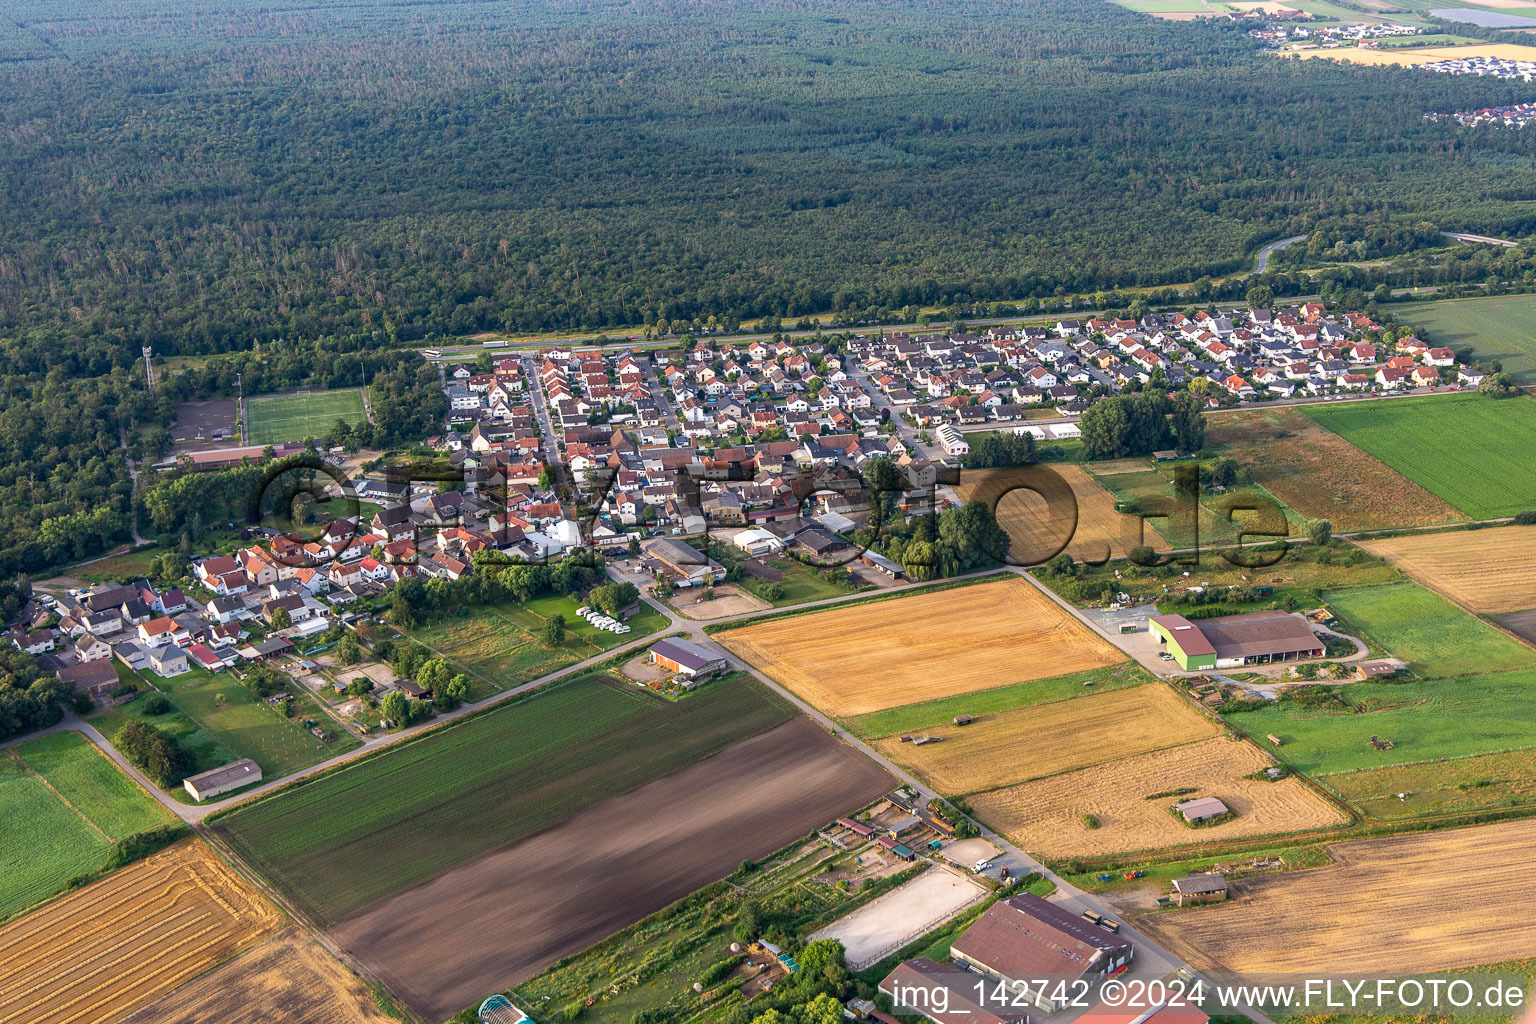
<box><xmin>1359</xmin><ymin>527</ymin><xmax>1536</xmax><ymax>613</ymax></box>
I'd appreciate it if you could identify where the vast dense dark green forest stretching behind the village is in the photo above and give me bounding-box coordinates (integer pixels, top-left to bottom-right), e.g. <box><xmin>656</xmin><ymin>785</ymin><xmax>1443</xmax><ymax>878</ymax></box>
<box><xmin>0</xmin><ymin>0</ymin><xmax>1533</xmax><ymax>353</ymax></box>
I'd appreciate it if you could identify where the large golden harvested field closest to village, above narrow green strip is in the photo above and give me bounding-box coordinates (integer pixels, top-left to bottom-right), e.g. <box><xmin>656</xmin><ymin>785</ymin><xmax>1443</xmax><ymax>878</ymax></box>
<box><xmin>714</xmin><ymin>576</ymin><xmax>1126</xmax><ymax>715</ymax></box>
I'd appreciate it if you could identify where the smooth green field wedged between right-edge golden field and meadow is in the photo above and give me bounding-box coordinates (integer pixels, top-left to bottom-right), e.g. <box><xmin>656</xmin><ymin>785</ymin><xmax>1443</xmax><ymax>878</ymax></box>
<box><xmin>1324</xmin><ymin>583</ymin><xmax>1536</xmax><ymax>677</ymax></box>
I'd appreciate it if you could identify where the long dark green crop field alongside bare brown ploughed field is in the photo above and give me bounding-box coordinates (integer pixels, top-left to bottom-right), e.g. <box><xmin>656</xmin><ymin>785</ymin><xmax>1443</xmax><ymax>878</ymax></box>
<box><xmin>217</xmin><ymin>677</ymin><xmax>793</xmax><ymax>923</ymax></box>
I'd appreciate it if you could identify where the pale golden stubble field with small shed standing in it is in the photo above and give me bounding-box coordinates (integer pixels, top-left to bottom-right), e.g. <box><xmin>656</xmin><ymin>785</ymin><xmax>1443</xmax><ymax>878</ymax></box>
<box><xmin>969</xmin><ymin>735</ymin><xmax>1349</xmax><ymax>857</ymax></box>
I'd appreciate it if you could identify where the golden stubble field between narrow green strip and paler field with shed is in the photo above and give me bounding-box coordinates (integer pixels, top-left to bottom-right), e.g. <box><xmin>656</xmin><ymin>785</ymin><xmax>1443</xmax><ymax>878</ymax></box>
<box><xmin>876</xmin><ymin>683</ymin><xmax>1220</xmax><ymax>794</ymax></box>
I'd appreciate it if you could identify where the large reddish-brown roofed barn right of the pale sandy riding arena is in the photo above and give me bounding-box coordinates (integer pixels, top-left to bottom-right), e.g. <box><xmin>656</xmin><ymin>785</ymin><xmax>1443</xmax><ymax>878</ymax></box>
<box><xmin>949</xmin><ymin>892</ymin><xmax>1135</xmax><ymax>1013</ymax></box>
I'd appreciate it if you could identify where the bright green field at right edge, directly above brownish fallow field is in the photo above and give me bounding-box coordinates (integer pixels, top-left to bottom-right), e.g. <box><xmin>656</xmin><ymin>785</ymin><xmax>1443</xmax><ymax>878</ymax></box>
<box><xmin>1306</xmin><ymin>393</ymin><xmax>1536</xmax><ymax>519</ymax></box>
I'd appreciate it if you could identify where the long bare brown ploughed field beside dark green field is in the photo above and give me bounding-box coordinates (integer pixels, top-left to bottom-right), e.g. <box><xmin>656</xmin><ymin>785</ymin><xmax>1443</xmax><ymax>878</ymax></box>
<box><xmin>332</xmin><ymin>718</ymin><xmax>894</xmax><ymax>1021</ymax></box>
